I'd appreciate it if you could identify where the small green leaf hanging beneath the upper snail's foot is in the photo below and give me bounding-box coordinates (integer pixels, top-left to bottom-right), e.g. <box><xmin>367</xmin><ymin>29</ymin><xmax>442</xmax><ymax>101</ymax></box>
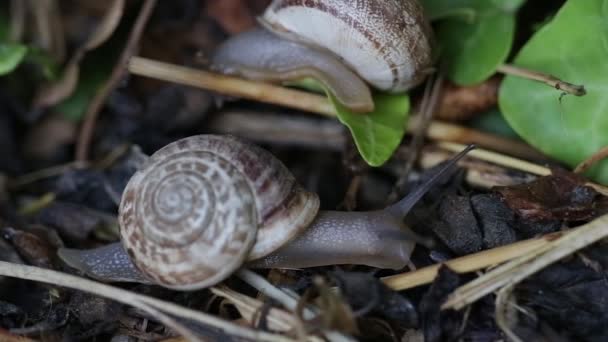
<box><xmin>328</xmin><ymin>92</ymin><xmax>410</xmax><ymax>166</ymax></box>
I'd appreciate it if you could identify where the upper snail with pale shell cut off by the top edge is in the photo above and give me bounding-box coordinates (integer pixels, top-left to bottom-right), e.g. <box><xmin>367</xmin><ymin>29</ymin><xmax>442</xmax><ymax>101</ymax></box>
<box><xmin>211</xmin><ymin>0</ymin><xmax>434</xmax><ymax>112</ymax></box>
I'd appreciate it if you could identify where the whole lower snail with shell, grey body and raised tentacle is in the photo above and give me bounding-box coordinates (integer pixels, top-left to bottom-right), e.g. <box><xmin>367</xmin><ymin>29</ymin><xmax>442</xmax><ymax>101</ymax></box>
<box><xmin>59</xmin><ymin>135</ymin><xmax>473</xmax><ymax>290</ymax></box>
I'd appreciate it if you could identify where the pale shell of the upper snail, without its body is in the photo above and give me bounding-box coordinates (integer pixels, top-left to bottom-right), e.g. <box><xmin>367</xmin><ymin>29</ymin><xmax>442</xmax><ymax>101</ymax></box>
<box><xmin>261</xmin><ymin>0</ymin><xmax>433</xmax><ymax>91</ymax></box>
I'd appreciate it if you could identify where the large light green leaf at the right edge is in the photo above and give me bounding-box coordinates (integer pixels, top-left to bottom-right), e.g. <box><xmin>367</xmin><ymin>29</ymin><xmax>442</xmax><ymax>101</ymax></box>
<box><xmin>499</xmin><ymin>0</ymin><xmax>608</xmax><ymax>184</ymax></box>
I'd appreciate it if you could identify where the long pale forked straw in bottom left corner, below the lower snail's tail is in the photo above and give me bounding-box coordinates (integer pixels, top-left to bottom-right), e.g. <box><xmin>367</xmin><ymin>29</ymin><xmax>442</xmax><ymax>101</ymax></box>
<box><xmin>0</xmin><ymin>261</ymin><xmax>291</xmax><ymax>341</ymax></box>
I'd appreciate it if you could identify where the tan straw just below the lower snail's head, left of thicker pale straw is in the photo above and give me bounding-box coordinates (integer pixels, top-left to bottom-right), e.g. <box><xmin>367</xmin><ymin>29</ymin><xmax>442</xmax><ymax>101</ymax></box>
<box><xmin>382</xmin><ymin>233</ymin><xmax>562</xmax><ymax>291</ymax></box>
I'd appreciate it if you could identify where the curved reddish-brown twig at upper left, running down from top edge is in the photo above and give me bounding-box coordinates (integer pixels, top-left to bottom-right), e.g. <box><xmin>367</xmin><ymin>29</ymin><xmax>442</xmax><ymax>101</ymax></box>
<box><xmin>76</xmin><ymin>0</ymin><xmax>156</xmax><ymax>161</ymax></box>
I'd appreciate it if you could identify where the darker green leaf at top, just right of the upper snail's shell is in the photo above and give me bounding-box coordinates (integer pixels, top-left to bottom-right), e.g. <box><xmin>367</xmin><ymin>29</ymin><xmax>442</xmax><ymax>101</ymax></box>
<box><xmin>422</xmin><ymin>0</ymin><xmax>525</xmax><ymax>85</ymax></box>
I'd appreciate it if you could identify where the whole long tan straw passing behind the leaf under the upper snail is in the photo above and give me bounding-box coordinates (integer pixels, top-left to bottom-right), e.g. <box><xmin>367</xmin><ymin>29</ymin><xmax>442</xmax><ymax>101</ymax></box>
<box><xmin>128</xmin><ymin>57</ymin><xmax>545</xmax><ymax>159</ymax></box>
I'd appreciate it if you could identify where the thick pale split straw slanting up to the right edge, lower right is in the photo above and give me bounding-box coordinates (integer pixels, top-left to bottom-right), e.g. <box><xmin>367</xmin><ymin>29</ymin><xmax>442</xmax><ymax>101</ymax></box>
<box><xmin>441</xmin><ymin>211</ymin><xmax>608</xmax><ymax>310</ymax></box>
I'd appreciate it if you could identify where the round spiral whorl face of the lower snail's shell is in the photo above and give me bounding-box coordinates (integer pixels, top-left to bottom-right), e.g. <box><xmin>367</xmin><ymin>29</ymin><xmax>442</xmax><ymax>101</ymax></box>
<box><xmin>119</xmin><ymin>138</ymin><xmax>257</xmax><ymax>289</ymax></box>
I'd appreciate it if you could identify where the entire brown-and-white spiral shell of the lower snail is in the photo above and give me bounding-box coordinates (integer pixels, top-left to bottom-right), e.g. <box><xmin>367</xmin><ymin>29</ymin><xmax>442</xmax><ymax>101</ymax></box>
<box><xmin>119</xmin><ymin>135</ymin><xmax>319</xmax><ymax>290</ymax></box>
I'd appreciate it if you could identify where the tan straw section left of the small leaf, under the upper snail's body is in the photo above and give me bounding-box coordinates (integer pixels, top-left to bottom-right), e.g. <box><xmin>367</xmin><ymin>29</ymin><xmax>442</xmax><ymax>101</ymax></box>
<box><xmin>128</xmin><ymin>57</ymin><xmax>336</xmax><ymax>117</ymax></box>
